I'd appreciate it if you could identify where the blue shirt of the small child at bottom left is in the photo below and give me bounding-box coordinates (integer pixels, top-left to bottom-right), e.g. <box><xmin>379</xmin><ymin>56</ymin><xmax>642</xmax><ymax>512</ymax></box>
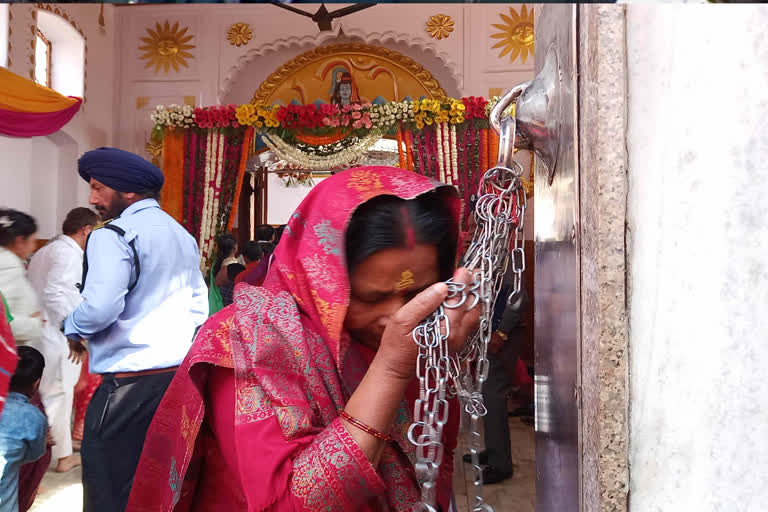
<box><xmin>0</xmin><ymin>392</ymin><xmax>48</xmax><ymax>512</ymax></box>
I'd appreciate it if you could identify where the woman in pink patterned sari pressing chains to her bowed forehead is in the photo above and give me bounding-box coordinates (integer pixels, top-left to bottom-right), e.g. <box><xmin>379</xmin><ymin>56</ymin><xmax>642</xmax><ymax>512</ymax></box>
<box><xmin>127</xmin><ymin>167</ymin><xmax>477</xmax><ymax>512</ymax></box>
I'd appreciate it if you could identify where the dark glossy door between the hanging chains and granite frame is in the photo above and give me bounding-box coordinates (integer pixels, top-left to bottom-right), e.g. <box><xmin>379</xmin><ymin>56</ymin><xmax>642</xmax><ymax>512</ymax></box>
<box><xmin>534</xmin><ymin>4</ymin><xmax>581</xmax><ymax>512</ymax></box>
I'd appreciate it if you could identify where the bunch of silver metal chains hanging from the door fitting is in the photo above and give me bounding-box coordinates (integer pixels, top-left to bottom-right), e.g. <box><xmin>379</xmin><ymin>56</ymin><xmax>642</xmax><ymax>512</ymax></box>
<box><xmin>408</xmin><ymin>113</ymin><xmax>527</xmax><ymax>512</ymax></box>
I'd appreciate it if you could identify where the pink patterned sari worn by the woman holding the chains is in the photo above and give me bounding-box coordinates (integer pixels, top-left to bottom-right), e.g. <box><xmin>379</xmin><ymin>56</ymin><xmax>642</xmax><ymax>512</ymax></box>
<box><xmin>127</xmin><ymin>167</ymin><xmax>461</xmax><ymax>512</ymax></box>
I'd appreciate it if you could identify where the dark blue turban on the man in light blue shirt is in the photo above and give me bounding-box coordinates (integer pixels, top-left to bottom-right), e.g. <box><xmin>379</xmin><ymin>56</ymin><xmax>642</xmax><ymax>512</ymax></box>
<box><xmin>77</xmin><ymin>148</ymin><xmax>165</xmax><ymax>193</ymax></box>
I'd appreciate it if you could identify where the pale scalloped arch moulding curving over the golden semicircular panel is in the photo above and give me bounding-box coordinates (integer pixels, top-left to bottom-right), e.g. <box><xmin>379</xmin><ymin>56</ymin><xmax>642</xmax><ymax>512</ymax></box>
<box><xmin>218</xmin><ymin>24</ymin><xmax>463</xmax><ymax>103</ymax></box>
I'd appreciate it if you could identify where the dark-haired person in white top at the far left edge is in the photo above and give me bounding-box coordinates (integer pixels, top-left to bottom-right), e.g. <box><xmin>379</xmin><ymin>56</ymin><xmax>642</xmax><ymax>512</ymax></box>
<box><xmin>0</xmin><ymin>208</ymin><xmax>43</xmax><ymax>345</ymax></box>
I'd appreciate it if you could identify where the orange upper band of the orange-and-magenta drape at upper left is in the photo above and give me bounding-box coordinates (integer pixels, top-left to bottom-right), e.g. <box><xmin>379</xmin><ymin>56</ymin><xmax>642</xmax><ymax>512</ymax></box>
<box><xmin>0</xmin><ymin>67</ymin><xmax>80</xmax><ymax>113</ymax></box>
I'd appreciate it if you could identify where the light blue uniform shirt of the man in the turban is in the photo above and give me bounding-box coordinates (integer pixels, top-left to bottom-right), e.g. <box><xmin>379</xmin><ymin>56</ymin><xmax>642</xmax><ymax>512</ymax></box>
<box><xmin>64</xmin><ymin>199</ymin><xmax>208</xmax><ymax>373</ymax></box>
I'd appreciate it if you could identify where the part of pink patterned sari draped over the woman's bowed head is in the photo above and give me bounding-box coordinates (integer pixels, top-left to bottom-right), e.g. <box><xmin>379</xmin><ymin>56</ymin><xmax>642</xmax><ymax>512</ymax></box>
<box><xmin>264</xmin><ymin>167</ymin><xmax>461</xmax><ymax>364</ymax></box>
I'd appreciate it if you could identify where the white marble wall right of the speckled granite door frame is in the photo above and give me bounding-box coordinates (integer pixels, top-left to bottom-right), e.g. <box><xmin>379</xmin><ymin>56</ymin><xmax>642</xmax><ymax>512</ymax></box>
<box><xmin>627</xmin><ymin>5</ymin><xmax>768</xmax><ymax>512</ymax></box>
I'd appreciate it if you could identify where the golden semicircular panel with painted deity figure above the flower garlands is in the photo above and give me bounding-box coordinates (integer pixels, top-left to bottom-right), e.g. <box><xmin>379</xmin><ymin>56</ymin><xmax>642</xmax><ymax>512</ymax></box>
<box><xmin>252</xmin><ymin>43</ymin><xmax>445</xmax><ymax>105</ymax></box>
